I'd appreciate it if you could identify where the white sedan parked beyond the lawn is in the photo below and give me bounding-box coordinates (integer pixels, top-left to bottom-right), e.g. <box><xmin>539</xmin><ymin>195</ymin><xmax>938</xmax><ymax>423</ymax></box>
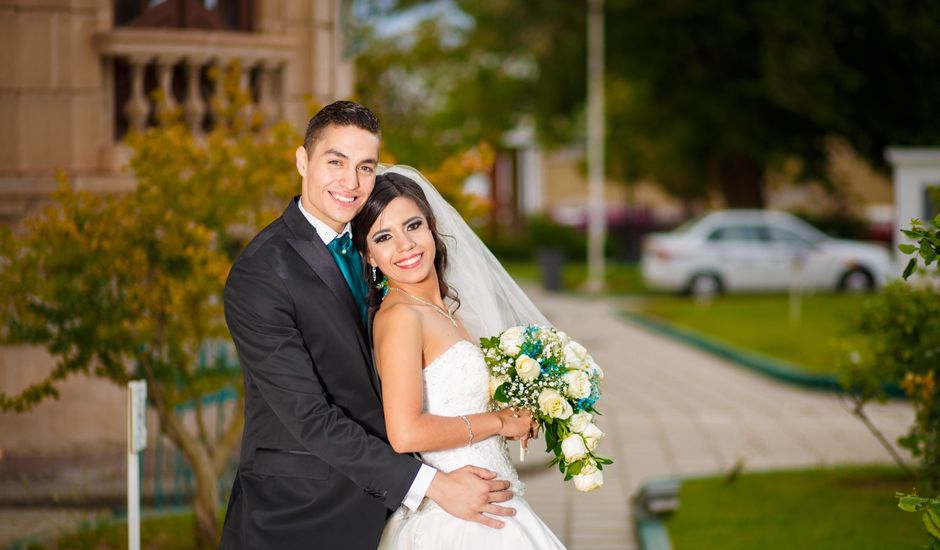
<box><xmin>641</xmin><ymin>210</ymin><xmax>898</xmax><ymax>294</ymax></box>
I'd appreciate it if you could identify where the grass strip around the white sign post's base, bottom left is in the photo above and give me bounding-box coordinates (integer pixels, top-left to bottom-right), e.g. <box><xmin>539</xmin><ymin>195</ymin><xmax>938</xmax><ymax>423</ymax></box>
<box><xmin>35</xmin><ymin>511</ymin><xmax>209</xmax><ymax>550</ymax></box>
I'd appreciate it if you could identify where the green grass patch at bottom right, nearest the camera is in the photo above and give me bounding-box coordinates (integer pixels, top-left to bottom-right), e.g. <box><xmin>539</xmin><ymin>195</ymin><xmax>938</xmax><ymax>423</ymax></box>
<box><xmin>667</xmin><ymin>467</ymin><xmax>929</xmax><ymax>550</ymax></box>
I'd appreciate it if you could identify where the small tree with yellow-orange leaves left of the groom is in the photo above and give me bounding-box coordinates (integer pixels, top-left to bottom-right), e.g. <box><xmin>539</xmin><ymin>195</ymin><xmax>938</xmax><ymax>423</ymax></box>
<box><xmin>0</xmin><ymin>66</ymin><xmax>300</xmax><ymax>548</ymax></box>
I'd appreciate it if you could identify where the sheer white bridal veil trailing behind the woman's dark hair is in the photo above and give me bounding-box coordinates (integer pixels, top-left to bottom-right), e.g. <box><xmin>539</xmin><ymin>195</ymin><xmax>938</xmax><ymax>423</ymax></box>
<box><xmin>380</xmin><ymin>165</ymin><xmax>550</xmax><ymax>338</ymax></box>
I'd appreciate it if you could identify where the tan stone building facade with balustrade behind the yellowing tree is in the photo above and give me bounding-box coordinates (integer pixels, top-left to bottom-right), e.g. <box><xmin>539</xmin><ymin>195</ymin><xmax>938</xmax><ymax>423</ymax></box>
<box><xmin>0</xmin><ymin>0</ymin><xmax>353</xmax><ymax>466</ymax></box>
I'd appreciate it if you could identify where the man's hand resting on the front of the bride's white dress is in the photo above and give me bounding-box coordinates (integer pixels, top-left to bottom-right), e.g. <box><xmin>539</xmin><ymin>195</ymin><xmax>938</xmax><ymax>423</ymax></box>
<box><xmin>427</xmin><ymin>466</ymin><xmax>516</xmax><ymax>529</ymax></box>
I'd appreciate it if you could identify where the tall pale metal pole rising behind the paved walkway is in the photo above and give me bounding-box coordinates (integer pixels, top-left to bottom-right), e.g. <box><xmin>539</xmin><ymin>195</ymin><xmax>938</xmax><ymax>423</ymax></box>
<box><xmin>586</xmin><ymin>0</ymin><xmax>607</xmax><ymax>292</ymax></box>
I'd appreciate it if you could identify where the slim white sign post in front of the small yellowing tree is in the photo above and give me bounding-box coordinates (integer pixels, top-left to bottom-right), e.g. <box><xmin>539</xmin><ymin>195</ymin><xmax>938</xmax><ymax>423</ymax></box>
<box><xmin>127</xmin><ymin>380</ymin><xmax>147</xmax><ymax>550</ymax></box>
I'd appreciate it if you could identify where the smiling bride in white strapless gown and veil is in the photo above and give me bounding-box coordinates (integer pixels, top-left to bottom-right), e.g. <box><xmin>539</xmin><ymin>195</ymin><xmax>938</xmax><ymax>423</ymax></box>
<box><xmin>352</xmin><ymin>166</ymin><xmax>564</xmax><ymax>550</ymax></box>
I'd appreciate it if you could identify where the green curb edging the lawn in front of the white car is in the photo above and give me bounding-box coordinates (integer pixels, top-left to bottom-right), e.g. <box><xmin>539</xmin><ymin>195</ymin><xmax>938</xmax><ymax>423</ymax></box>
<box><xmin>620</xmin><ymin>310</ymin><xmax>907</xmax><ymax>399</ymax></box>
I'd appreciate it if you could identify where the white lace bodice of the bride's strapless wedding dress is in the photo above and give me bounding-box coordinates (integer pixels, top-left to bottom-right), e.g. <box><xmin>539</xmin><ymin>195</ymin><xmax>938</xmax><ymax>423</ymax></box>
<box><xmin>421</xmin><ymin>340</ymin><xmax>525</xmax><ymax>497</ymax></box>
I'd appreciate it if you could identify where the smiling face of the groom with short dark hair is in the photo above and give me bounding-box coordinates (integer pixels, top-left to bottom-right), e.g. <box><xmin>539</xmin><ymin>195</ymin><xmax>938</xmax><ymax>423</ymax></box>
<box><xmin>296</xmin><ymin>125</ymin><xmax>379</xmax><ymax>232</ymax></box>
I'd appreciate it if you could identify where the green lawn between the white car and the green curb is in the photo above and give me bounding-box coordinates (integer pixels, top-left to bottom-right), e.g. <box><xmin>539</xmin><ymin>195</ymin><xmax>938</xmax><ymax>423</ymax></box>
<box><xmin>634</xmin><ymin>294</ymin><xmax>865</xmax><ymax>373</ymax></box>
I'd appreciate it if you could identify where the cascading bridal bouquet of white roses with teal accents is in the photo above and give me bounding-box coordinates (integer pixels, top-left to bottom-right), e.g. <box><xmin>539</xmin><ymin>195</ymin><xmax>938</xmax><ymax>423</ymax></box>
<box><xmin>480</xmin><ymin>325</ymin><xmax>613</xmax><ymax>491</ymax></box>
